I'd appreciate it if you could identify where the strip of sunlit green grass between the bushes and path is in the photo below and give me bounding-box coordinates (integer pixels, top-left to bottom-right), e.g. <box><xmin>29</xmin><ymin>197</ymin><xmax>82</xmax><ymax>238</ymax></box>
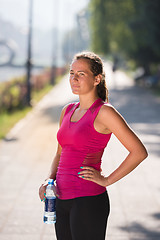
<box><xmin>0</xmin><ymin>85</ymin><xmax>53</xmax><ymax>139</ymax></box>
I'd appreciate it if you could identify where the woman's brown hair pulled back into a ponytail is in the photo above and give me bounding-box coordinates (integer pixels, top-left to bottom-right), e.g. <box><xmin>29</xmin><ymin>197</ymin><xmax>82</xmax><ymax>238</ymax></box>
<box><xmin>73</xmin><ymin>52</ymin><xmax>108</xmax><ymax>102</ymax></box>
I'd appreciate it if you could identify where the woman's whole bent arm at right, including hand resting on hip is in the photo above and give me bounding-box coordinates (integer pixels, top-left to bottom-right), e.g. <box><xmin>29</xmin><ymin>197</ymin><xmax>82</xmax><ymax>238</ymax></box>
<box><xmin>80</xmin><ymin>106</ymin><xmax>147</xmax><ymax>186</ymax></box>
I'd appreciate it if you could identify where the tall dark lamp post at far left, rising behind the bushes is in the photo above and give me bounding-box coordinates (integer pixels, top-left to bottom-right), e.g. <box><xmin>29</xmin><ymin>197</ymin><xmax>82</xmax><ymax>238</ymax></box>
<box><xmin>26</xmin><ymin>0</ymin><xmax>33</xmax><ymax>106</ymax></box>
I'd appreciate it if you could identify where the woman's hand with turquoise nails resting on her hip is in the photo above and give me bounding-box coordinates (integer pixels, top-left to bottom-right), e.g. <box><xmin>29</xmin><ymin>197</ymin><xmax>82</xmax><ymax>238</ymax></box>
<box><xmin>78</xmin><ymin>166</ymin><xmax>108</xmax><ymax>187</ymax></box>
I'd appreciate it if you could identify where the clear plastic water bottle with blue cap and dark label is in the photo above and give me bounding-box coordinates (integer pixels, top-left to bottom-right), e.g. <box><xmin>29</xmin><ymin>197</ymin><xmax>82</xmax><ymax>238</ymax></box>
<box><xmin>44</xmin><ymin>179</ymin><xmax>56</xmax><ymax>224</ymax></box>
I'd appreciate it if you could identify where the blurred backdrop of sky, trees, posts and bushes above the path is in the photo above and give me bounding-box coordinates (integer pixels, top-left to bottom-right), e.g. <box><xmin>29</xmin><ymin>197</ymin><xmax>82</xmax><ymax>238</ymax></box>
<box><xmin>0</xmin><ymin>0</ymin><xmax>160</xmax><ymax>138</ymax></box>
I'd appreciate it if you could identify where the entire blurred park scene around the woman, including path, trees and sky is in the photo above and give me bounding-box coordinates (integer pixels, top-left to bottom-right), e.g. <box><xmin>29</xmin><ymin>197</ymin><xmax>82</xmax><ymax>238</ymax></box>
<box><xmin>0</xmin><ymin>0</ymin><xmax>160</xmax><ymax>240</ymax></box>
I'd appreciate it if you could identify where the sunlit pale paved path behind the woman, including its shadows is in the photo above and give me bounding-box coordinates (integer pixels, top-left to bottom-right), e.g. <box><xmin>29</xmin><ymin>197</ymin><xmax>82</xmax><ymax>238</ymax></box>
<box><xmin>0</xmin><ymin>64</ymin><xmax>160</xmax><ymax>240</ymax></box>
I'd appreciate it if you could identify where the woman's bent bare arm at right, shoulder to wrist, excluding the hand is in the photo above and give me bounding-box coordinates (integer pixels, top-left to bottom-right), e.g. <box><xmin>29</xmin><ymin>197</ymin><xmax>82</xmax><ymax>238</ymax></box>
<box><xmin>106</xmin><ymin>107</ymin><xmax>148</xmax><ymax>185</ymax></box>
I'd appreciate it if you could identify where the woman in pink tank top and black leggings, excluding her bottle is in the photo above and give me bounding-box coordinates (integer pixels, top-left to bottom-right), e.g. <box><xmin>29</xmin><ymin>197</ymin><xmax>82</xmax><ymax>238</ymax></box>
<box><xmin>39</xmin><ymin>52</ymin><xmax>147</xmax><ymax>240</ymax></box>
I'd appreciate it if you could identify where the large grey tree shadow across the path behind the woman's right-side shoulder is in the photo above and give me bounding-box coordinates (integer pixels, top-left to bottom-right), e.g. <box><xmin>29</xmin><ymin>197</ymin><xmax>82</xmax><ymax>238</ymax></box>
<box><xmin>109</xmin><ymin>86</ymin><xmax>160</xmax><ymax>124</ymax></box>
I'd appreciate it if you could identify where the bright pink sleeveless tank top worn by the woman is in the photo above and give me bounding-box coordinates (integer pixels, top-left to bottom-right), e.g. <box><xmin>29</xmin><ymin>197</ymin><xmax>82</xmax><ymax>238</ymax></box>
<box><xmin>56</xmin><ymin>98</ymin><xmax>111</xmax><ymax>199</ymax></box>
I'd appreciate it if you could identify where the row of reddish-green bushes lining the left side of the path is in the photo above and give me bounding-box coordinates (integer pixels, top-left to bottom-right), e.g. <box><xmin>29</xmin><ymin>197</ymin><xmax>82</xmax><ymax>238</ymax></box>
<box><xmin>0</xmin><ymin>68</ymin><xmax>66</xmax><ymax>113</ymax></box>
